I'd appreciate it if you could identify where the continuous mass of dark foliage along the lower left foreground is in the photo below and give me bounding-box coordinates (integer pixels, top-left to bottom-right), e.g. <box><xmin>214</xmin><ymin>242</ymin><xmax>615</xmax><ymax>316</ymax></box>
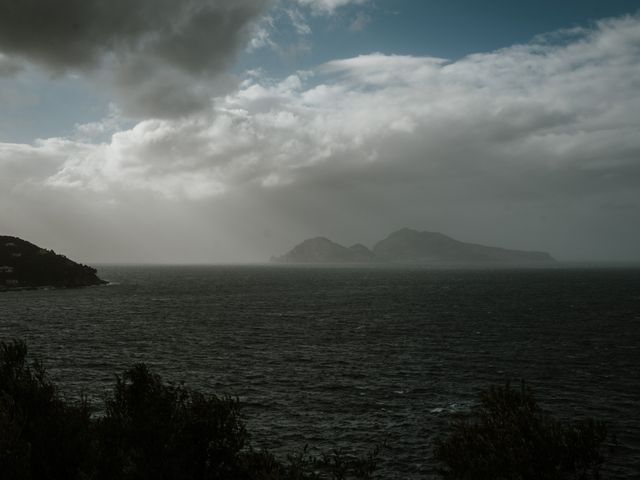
<box><xmin>0</xmin><ymin>342</ymin><xmax>376</xmax><ymax>480</ymax></box>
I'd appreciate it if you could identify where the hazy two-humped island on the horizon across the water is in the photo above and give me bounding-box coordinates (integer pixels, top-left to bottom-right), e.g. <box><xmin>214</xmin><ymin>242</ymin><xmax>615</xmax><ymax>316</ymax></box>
<box><xmin>272</xmin><ymin>228</ymin><xmax>554</xmax><ymax>264</ymax></box>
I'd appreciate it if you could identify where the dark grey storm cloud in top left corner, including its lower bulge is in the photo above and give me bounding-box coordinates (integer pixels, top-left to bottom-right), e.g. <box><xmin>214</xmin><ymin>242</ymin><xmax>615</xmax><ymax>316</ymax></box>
<box><xmin>0</xmin><ymin>0</ymin><xmax>269</xmax><ymax>116</ymax></box>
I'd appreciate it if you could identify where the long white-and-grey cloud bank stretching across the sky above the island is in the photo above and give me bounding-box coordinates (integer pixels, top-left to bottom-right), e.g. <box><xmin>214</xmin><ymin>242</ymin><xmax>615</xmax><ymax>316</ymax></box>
<box><xmin>0</xmin><ymin>17</ymin><xmax>640</xmax><ymax>258</ymax></box>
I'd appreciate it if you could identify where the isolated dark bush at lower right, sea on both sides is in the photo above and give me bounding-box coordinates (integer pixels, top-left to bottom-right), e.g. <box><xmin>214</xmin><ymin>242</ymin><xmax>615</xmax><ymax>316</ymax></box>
<box><xmin>434</xmin><ymin>384</ymin><xmax>607</xmax><ymax>480</ymax></box>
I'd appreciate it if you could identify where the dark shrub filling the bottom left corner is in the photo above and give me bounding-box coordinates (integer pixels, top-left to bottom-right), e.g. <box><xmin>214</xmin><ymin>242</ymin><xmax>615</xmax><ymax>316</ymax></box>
<box><xmin>0</xmin><ymin>341</ymin><xmax>90</xmax><ymax>480</ymax></box>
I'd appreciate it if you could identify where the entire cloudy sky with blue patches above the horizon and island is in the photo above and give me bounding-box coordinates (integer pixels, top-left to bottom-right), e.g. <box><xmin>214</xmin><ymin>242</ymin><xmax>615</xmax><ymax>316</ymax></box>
<box><xmin>0</xmin><ymin>0</ymin><xmax>640</xmax><ymax>263</ymax></box>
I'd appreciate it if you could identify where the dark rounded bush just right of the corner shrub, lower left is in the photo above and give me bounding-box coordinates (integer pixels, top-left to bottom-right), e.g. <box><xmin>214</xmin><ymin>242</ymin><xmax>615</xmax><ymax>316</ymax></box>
<box><xmin>97</xmin><ymin>365</ymin><xmax>252</xmax><ymax>480</ymax></box>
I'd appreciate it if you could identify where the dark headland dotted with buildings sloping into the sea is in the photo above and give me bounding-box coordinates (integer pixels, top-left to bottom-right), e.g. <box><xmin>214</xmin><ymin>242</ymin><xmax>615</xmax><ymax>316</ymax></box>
<box><xmin>0</xmin><ymin>235</ymin><xmax>106</xmax><ymax>291</ymax></box>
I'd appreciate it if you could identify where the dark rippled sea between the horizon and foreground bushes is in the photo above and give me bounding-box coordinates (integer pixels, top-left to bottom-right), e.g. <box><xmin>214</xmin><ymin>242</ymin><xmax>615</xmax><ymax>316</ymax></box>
<box><xmin>0</xmin><ymin>264</ymin><xmax>640</xmax><ymax>480</ymax></box>
